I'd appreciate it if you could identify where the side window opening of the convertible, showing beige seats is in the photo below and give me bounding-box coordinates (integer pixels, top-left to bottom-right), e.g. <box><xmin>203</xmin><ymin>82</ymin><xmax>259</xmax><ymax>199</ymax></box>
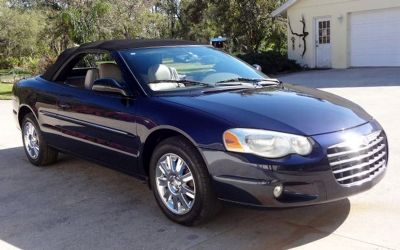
<box><xmin>57</xmin><ymin>52</ymin><xmax>123</xmax><ymax>90</ymax></box>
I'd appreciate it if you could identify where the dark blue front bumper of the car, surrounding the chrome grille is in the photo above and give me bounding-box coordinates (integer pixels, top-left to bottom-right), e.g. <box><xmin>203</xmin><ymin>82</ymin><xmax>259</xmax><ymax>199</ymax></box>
<box><xmin>201</xmin><ymin>121</ymin><xmax>388</xmax><ymax>207</ymax></box>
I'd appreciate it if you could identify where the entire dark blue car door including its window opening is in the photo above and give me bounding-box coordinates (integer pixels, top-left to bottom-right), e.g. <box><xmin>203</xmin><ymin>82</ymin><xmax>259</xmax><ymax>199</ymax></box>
<box><xmin>41</xmin><ymin>52</ymin><xmax>143</xmax><ymax>175</ymax></box>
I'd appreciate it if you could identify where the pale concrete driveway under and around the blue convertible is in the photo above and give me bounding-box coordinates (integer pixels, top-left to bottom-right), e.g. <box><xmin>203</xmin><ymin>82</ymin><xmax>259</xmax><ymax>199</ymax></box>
<box><xmin>0</xmin><ymin>69</ymin><xmax>400</xmax><ymax>249</ymax></box>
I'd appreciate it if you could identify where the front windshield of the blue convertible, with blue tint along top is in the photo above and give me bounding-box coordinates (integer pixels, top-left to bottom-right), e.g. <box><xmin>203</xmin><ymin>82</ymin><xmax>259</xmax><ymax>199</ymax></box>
<box><xmin>121</xmin><ymin>46</ymin><xmax>268</xmax><ymax>92</ymax></box>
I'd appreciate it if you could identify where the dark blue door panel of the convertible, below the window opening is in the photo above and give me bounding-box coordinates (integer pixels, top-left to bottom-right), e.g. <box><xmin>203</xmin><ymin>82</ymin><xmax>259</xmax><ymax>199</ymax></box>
<box><xmin>57</xmin><ymin>88</ymin><xmax>142</xmax><ymax>174</ymax></box>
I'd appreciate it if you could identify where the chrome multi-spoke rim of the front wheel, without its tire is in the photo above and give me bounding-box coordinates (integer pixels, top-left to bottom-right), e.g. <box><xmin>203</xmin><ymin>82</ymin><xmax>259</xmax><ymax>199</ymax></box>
<box><xmin>155</xmin><ymin>153</ymin><xmax>196</xmax><ymax>215</ymax></box>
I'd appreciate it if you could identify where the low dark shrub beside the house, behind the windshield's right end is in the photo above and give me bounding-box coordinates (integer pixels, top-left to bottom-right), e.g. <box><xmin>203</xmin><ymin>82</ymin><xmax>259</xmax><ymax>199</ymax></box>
<box><xmin>237</xmin><ymin>51</ymin><xmax>302</xmax><ymax>75</ymax></box>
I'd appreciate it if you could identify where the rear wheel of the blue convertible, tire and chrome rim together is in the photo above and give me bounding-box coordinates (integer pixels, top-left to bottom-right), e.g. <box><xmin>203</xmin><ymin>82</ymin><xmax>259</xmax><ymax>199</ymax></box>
<box><xmin>21</xmin><ymin>113</ymin><xmax>58</xmax><ymax>166</ymax></box>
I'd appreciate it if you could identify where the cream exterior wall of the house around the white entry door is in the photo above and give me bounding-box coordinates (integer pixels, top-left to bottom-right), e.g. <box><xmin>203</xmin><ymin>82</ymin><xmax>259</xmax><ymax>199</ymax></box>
<box><xmin>287</xmin><ymin>0</ymin><xmax>400</xmax><ymax>68</ymax></box>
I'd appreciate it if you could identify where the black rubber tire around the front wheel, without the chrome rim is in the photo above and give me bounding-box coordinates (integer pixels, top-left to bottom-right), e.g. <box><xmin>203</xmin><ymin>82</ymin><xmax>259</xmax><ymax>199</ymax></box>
<box><xmin>150</xmin><ymin>139</ymin><xmax>205</xmax><ymax>225</ymax></box>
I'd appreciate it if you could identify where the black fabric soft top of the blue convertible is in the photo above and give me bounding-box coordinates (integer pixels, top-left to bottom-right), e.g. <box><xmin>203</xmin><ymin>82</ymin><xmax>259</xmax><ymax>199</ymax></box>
<box><xmin>42</xmin><ymin>39</ymin><xmax>204</xmax><ymax>81</ymax></box>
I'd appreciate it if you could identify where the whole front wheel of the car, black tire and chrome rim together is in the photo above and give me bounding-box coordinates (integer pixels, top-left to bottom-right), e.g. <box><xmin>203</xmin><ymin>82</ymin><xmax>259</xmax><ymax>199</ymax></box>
<box><xmin>150</xmin><ymin>136</ymin><xmax>221</xmax><ymax>226</ymax></box>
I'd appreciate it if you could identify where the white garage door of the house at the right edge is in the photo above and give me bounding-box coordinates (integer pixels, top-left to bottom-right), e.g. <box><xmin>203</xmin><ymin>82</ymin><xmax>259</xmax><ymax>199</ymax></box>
<box><xmin>350</xmin><ymin>8</ymin><xmax>400</xmax><ymax>67</ymax></box>
